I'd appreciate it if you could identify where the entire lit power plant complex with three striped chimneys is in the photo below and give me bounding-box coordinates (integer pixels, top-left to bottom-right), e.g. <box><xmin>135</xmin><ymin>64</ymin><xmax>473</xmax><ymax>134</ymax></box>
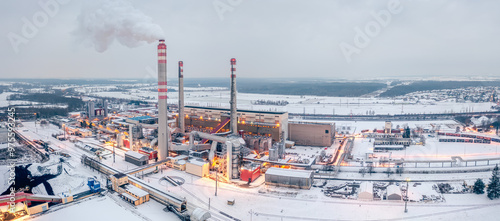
<box><xmin>6</xmin><ymin>39</ymin><xmax>334</xmax><ymax>220</ymax></box>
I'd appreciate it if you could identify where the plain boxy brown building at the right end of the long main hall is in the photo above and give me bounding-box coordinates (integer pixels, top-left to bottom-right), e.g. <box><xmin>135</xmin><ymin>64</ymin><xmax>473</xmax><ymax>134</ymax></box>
<box><xmin>288</xmin><ymin>122</ymin><xmax>335</xmax><ymax>147</ymax></box>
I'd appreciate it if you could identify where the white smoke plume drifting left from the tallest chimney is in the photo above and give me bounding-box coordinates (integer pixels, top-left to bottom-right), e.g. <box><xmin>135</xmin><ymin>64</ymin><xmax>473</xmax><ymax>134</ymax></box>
<box><xmin>74</xmin><ymin>0</ymin><xmax>164</xmax><ymax>52</ymax></box>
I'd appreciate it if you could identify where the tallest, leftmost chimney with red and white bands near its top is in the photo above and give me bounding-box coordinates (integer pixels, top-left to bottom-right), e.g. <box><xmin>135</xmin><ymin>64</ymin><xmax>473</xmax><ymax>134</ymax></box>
<box><xmin>158</xmin><ymin>39</ymin><xmax>169</xmax><ymax>160</ymax></box>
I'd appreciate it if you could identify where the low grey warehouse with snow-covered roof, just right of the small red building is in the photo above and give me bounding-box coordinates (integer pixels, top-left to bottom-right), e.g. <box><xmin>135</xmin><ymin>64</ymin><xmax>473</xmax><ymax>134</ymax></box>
<box><xmin>265</xmin><ymin>167</ymin><xmax>313</xmax><ymax>189</ymax></box>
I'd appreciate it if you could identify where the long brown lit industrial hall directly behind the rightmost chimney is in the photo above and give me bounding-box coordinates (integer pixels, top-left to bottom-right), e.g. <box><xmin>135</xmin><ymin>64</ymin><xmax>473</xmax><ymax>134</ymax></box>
<box><xmin>184</xmin><ymin>106</ymin><xmax>288</xmax><ymax>142</ymax></box>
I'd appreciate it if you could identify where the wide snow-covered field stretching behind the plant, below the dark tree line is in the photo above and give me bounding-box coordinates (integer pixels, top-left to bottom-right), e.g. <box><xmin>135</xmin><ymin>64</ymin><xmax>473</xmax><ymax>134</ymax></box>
<box><xmin>87</xmin><ymin>87</ymin><xmax>495</xmax><ymax>115</ymax></box>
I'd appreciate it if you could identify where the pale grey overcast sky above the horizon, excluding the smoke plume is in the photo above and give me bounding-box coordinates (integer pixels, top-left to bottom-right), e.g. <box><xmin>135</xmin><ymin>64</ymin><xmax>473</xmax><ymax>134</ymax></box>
<box><xmin>0</xmin><ymin>0</ymin><xmax>500</xmax><ymax>79</ymax></box>
